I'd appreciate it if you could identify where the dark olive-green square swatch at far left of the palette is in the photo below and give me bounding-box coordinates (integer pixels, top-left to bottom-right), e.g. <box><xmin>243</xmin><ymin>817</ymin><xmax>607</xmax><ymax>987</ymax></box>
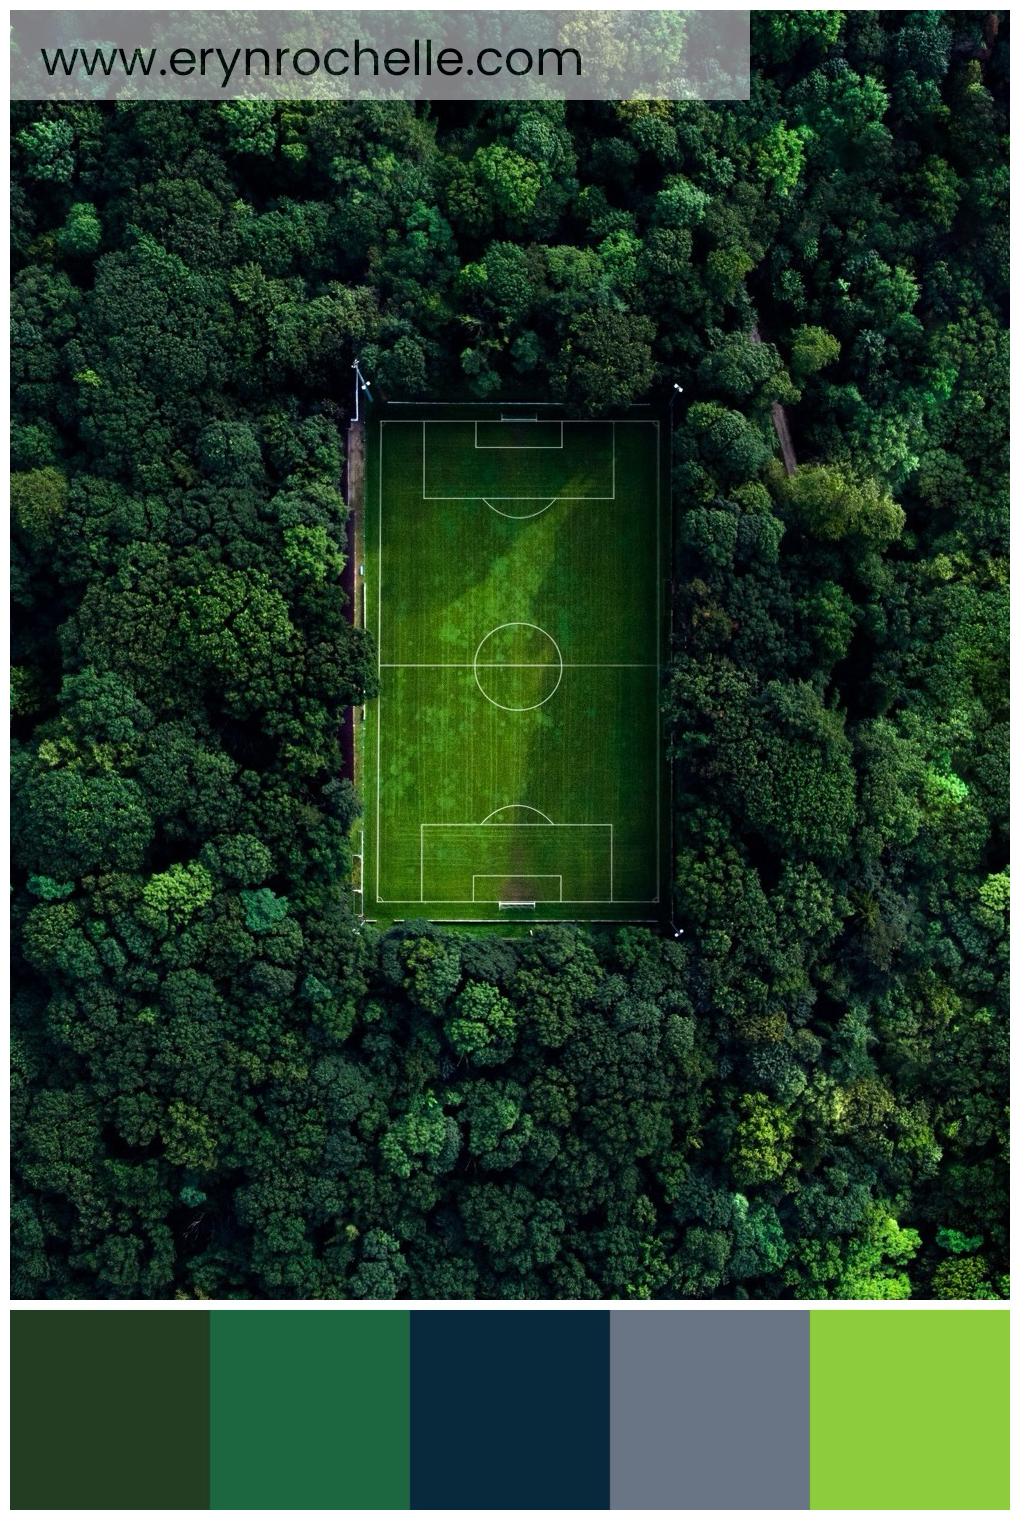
<box><xmin>11</xmin><ymin>1309</ymin><xmax>208</xmax><ymax>1509</ymax></box>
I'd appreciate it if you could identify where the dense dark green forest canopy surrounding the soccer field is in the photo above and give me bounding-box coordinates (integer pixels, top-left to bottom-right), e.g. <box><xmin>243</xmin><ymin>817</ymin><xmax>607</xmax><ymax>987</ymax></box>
<box><xmin>11</xmin><ymin>11</ymin><xmax>1008</xmax><ymax>1300</ymax></box>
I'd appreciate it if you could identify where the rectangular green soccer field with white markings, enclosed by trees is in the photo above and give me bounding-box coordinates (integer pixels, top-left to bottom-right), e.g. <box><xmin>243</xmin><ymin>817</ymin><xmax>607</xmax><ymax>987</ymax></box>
<box><xmin>362</xmin><ymin>407</ymin><xmax>667</xmax><ymax>921</ymax></box>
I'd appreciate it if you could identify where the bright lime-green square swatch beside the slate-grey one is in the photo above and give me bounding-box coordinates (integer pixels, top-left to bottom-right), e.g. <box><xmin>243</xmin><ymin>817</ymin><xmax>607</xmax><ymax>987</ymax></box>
<box><xmin>810</xmin><ymin>1309</ymin><xmax>1009</xmax><ymax>1509</ymax></box>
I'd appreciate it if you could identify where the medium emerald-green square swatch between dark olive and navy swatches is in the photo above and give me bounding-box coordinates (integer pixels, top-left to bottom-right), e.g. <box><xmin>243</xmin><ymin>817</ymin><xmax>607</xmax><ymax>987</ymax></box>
<box><xmin>210</xmin><ymin>1309</ymin><xmax>410</xmax><ymax>1509</ymax></box>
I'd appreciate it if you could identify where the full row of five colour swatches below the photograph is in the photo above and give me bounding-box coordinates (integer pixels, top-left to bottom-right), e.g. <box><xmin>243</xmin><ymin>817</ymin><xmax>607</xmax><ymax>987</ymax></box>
<box><xmin>11</xmin><ymin>1304</ymin><xmax>1009</xmax><ymax>1511</ymax></box>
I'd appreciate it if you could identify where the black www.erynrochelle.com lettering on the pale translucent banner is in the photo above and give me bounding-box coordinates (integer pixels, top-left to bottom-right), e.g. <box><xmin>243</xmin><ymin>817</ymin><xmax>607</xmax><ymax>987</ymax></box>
<box><xmin>40</xmin><ymin>38</ymin><xmax>581</xmax><ymax>90</ymax></box>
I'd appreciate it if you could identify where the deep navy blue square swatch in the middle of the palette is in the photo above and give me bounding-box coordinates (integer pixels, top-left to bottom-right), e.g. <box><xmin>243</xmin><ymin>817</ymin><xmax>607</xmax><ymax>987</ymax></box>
<box><xmin>410</xmin><ymin>1309</ymin><xmax>610</xmax><ymax>1509</ymax></box>
